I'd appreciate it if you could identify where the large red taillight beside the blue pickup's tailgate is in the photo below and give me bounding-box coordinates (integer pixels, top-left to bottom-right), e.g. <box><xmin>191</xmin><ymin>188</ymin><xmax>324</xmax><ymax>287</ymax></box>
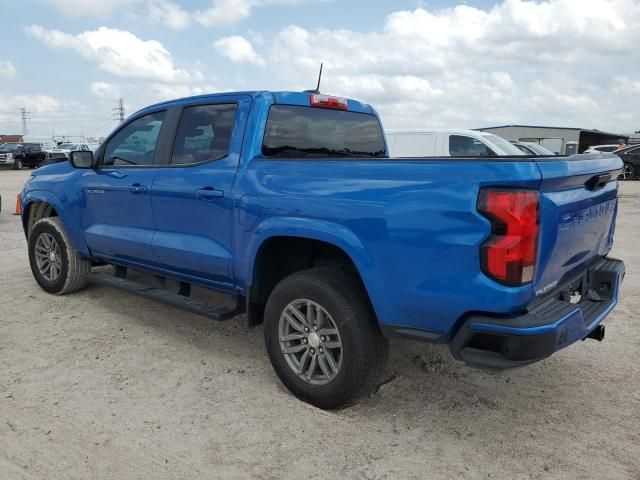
<box><xmin>478</xmin><ymin>189</ymin><xmax>539</xmax><ymax>286</ymax></box>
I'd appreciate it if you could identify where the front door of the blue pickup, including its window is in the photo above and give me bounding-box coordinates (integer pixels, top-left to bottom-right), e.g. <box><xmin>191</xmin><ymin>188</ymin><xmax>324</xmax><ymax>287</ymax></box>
<box><xmin>82</xmin><ymin>111</ymin><xmax>165</xmax><ymax>263</ymax></box>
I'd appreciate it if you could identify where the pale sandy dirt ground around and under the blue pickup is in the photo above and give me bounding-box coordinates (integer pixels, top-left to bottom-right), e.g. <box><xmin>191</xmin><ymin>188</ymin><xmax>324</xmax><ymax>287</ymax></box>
<box><xmin>0</xmin><ymin>171</ymin><xmax>640</xmax><ymax>480</ymax></box>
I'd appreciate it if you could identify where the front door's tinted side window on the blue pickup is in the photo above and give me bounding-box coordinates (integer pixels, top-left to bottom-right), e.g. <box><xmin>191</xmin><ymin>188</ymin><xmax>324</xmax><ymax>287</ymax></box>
<box><xmin>102</xmin><ymin>112</ymin><xmax>165</xmax><ymax>166</ymax></box>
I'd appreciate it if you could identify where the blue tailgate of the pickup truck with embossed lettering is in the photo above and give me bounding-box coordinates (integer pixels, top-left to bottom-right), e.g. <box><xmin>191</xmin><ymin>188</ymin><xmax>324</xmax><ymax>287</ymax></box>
<box><xmin>534</xmin><ymin>154</ymin><xmax>622</xmax><ymax>296</ymax></box>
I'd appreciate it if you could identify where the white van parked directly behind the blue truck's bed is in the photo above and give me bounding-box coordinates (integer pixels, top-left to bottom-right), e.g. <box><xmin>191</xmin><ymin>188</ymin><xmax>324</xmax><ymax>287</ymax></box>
<box><xmin>385</xmin><ymin>129</ymin><xmax>525</xmax><ymax>157</ymax></box>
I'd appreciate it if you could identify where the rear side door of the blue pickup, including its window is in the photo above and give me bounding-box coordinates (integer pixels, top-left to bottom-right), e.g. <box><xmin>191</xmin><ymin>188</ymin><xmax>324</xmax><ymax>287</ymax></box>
<box><xmin>152</xmin><ymin>97</ymin><xmax>250</xmax><ymax>286</ymax></box>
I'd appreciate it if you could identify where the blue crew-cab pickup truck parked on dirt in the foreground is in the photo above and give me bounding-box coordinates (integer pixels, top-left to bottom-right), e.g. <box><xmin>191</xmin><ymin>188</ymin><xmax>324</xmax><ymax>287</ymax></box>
<box><xmin>21</xmin><ymin>91</ymin><xmax>624</xmax><ymax>408</ymax></box>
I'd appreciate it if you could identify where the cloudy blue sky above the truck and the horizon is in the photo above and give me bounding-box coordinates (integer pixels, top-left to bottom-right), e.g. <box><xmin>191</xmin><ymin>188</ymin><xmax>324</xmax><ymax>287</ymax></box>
<box><xmin>0</xmin><ymin>0</ymin><xmax>640</xmax><ymax>135</ymax></box>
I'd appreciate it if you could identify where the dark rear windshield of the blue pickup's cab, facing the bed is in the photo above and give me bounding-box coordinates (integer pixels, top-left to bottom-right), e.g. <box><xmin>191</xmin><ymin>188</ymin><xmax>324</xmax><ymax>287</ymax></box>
<box><xmin>262</xmin><ymin>105</ymin><xmax>385</xmax><ymax>158</ymax></box>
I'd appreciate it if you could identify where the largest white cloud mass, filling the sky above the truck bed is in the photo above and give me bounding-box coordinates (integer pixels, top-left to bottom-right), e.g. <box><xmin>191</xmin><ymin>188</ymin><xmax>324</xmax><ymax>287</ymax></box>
<box><xmin>206</xmin><ymin>0</ymin><xmax>640</xmax><ymax>131</ymax></box>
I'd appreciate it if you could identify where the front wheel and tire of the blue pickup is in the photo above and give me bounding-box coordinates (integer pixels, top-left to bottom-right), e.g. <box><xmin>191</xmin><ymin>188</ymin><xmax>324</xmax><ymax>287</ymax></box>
<box><xmin>28</xmin><ymin>217</ymin><xmax>91</xmax><ymax>295</ymax></box>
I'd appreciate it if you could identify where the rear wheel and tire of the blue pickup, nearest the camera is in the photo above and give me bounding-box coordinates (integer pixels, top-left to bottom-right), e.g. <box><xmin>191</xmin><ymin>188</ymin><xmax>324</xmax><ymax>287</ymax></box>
<box><xmin>264</xmin><ymin>267</ymin><xmax>388</xmax><ymax>408</ymax></box>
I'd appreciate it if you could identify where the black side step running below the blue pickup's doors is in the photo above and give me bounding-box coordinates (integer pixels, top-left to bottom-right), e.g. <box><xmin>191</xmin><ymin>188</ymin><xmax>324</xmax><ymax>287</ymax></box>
<box><xmin>85</xmin><ymin>272</ymin><xmax>245</xmax><ymax>320</ymax></box>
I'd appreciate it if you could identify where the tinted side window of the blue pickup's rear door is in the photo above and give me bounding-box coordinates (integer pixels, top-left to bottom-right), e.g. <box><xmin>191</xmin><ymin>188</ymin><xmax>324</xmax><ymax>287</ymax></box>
<box><xmin>171</xmin><ymin>103</ymin><xmax>237</xmax><ymax>165</ymax></box>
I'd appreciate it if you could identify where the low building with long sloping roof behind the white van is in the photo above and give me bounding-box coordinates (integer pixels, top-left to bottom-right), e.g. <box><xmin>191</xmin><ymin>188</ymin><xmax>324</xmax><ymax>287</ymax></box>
<box><xmin>477</xmin><ymin>125</ymin><xmax>629</xmax><ymax>155</ymax></box>
